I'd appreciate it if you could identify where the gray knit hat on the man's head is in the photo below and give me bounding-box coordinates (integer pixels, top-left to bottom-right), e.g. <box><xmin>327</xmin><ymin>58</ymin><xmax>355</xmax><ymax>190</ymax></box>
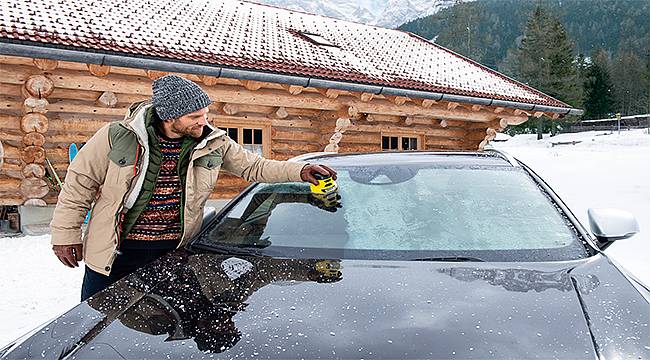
<box><xmin>151</xmin><ymin>75</ymin><xmax>212</xmax><ymax>120</ymax></box>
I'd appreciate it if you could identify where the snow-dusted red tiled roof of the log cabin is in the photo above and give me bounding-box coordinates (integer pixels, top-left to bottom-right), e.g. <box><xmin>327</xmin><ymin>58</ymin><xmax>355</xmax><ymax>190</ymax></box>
<box><xmin>0</xmin><ymin>0</ymin><xmax>569</xmax><ymax>108</ymax></box>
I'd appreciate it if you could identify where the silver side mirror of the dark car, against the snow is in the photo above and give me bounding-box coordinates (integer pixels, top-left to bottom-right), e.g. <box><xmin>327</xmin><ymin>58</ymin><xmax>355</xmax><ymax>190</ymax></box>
<box><xmin>587</xmin><ymin>209</ymin><xmax>639</xmax><ymax>250</ymax></box>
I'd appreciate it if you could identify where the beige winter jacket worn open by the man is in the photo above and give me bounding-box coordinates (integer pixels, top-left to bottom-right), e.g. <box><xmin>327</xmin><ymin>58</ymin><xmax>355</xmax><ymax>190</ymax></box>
<box><xmin>50</xmin><ymin>102</ymin><xmax>306</xmax><ymax>275</ymax></box>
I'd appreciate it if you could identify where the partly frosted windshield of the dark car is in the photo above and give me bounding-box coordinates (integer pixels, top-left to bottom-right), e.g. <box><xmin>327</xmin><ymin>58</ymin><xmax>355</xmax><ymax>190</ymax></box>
<box><xmin>195</xmin><ymin>155</ymin><xmax>587</xmax><ymax>261</ymax></box>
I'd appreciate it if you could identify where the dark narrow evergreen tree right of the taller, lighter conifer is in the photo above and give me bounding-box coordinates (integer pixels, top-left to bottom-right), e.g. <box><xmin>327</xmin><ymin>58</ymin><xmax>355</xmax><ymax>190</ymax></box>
<box><xmin>583</xmin><ymin>49</ymin><xmax>616</xmax><ymax>119</ymax></box>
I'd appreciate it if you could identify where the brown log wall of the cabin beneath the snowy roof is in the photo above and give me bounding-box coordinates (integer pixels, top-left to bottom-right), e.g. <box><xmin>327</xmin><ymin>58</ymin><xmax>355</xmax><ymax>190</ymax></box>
<box><xmin>0</xmin><ymin>56</ymin><xmax>541</xmax><ymax>205</ymax></box>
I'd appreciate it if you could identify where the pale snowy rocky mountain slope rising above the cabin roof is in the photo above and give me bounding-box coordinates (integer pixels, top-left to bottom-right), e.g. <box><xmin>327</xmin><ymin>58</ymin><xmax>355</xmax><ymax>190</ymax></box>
<box><xmin>248</xmin><ymin>0</ymin><xmax>457</xmax><ymax>28</ymax></box>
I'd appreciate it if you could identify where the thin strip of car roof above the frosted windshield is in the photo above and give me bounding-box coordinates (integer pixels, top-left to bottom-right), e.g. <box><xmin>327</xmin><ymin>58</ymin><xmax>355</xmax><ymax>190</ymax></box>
<box><xmin>290</xmin><ymin>149</ymin><xmax>520</xmax><ymax>167</ymax></box>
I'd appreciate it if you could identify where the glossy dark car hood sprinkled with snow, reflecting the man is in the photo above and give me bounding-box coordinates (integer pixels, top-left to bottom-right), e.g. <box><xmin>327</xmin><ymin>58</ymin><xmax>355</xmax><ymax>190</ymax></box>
<box><xmin>4</xmin><ymin>251</ymin><xmax>650</xmax><ymax>359</ymax></box>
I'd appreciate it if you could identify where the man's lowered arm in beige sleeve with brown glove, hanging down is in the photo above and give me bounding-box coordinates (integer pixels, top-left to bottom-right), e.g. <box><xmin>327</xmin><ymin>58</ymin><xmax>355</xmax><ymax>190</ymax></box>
<box><xmin>50</xmin><ymin>125</ymin><xmax>110</xmax><ymax>267</ymax></box>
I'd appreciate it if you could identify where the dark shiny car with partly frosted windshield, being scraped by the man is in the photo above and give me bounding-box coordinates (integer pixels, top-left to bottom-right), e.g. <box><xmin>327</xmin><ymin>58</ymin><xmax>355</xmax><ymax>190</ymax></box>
<box><xmin>0</xmin><ymin>150</ymin><xmax>650</xmax><ymax>359</ymax></box>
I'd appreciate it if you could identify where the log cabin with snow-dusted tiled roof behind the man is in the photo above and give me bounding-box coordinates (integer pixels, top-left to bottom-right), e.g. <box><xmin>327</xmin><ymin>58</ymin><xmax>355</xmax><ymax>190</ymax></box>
<box><xmin>0</xmin><ymin>0</ymin><xmax>581</xmax><ymax>214</ymax></box>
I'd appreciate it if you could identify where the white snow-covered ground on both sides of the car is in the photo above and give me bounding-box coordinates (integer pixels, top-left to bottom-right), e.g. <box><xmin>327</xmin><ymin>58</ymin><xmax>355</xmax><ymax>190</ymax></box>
<box><xmin>0</xmin><ymin>130</ymin><xmax>650</xmax><ymax>347</ymax></box>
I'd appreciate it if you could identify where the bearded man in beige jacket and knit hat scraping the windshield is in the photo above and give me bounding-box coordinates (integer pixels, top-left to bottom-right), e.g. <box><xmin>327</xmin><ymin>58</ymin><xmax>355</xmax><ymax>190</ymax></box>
<box><xmin>51</xmin><ymin>75</ymin><xmax>336</xmax><ymax>300</ymax></box>
